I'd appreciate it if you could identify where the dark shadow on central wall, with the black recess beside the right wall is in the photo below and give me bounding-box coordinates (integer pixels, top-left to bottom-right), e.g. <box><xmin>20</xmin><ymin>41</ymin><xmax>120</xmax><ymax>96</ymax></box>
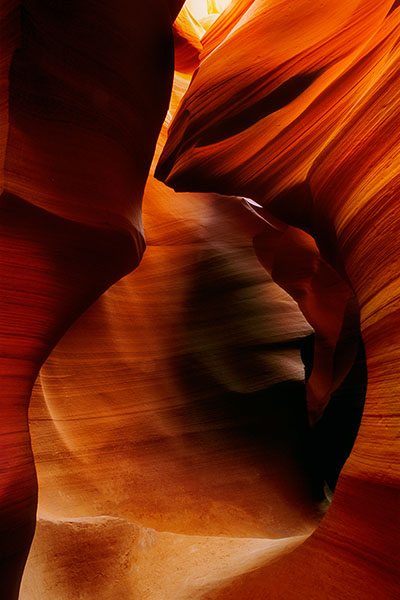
<box><xmin>176</xmin><ymin>244</ymin><xmax>366</xmax><ymax>533</ymax></box>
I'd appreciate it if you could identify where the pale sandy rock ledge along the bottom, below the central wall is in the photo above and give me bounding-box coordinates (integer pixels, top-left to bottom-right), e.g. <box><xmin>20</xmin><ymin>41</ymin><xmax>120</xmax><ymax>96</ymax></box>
<box><xmin>23</xmin><ymin>517</ymin><xmax>304</xmax><ymax>600</ymax></box>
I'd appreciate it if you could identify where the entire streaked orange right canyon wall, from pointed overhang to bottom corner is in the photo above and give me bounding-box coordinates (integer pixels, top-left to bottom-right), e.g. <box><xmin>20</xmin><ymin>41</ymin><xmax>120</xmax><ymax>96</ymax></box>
<box><xmin>157</xmin><ymin>1</ymin><xmax>400</xmax><ymax>600</ymax></box>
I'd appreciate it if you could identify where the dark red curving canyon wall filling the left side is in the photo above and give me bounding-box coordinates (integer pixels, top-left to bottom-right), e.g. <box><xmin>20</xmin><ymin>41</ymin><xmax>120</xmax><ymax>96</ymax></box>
<box><xmin>0</xmin><ymin>0</ymin><xmax>183</xmax><ymax>598</ymax></box>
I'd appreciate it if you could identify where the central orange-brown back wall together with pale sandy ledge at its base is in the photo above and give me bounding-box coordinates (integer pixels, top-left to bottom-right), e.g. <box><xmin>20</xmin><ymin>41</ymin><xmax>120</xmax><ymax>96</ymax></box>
<box><xmin>21</xmin><ymin>77</ymin><xmax>324</xmax><ymax>600</ymax></box>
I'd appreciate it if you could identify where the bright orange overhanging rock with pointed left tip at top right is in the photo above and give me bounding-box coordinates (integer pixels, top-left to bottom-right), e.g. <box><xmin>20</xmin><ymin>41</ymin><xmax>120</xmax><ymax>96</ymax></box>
<box><xmin>156</xmin><ymin>0</ymin><xmax>398</xmax><ymax>202</ymax></box>
